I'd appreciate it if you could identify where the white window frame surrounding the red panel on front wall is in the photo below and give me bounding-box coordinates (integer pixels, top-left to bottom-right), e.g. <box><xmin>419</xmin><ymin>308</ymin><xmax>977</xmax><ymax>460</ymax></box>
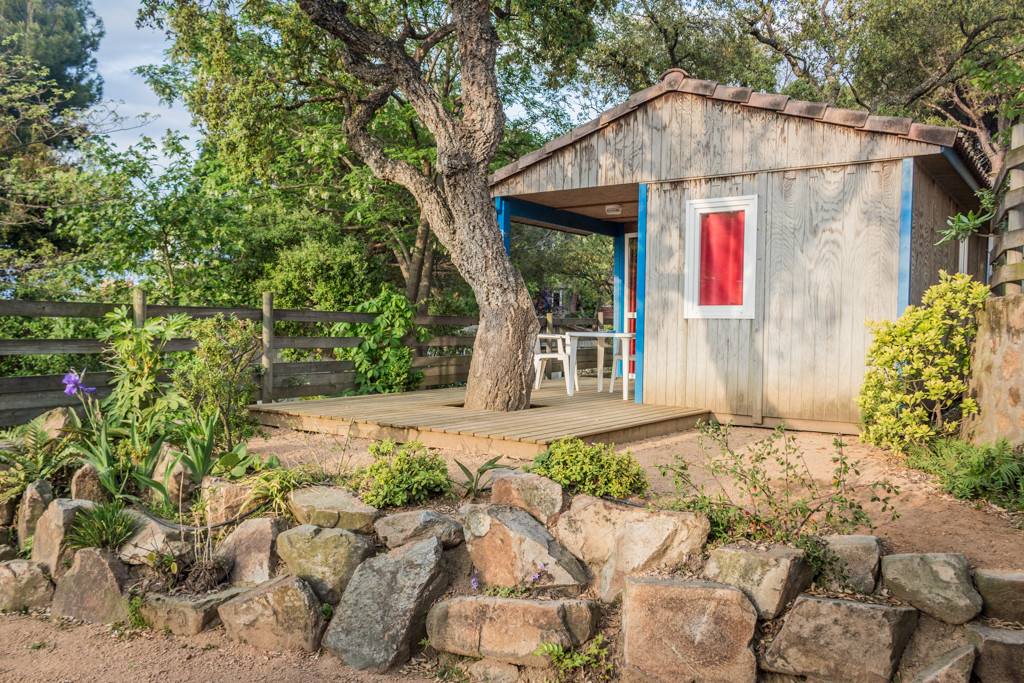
<box><xmin>683</xmin><ymin>195</ymin><xmax>758</xmax><ymax>319</ymax></box>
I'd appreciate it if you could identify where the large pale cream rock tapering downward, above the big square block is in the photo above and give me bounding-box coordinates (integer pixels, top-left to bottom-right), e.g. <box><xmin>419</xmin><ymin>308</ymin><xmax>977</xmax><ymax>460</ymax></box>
<box><xmin>555</xmin><ymin>496</ymin><xmax>711</xmax><ymax>602</ymax></box>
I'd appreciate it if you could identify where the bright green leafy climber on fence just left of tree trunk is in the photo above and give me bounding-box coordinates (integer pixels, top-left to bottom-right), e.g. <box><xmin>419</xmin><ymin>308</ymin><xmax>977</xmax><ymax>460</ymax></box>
<box><xmin>333</xmin><ymin>285</ymin><xmax>429</xmax><ymax>393</ymax></box>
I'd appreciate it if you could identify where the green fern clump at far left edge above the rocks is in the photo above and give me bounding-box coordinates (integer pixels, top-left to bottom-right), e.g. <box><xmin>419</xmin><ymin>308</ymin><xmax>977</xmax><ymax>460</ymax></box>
<box><xmin>0</xmin><ymin>416</ymin><xmax>72</xmax><ymax>503</ymax></box>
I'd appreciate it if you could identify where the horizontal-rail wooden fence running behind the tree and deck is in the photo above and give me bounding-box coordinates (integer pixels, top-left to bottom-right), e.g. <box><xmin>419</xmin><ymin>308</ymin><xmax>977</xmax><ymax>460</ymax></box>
<box><xmin>0</xmin><ymin>290</ymin><xmax>603</xmax><ymax>427</ymax></box>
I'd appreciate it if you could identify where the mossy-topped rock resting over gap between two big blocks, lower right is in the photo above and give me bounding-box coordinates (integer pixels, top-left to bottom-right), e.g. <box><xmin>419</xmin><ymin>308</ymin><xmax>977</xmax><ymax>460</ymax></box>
<box><xmin>705</xmin><ymin>546</ymin><xmax>814</xmax><ymax>618</ymax></box>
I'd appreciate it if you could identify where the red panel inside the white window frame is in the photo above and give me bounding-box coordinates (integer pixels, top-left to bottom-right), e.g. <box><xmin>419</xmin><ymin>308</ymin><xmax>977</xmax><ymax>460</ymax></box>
<box><xmin>699</xmin><ymin>211</ymin><xmax>745</xmax><ymax>306</ymax></box>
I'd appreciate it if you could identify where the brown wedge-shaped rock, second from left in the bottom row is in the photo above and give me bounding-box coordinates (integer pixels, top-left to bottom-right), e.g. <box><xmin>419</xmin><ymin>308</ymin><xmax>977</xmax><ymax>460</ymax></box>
<box><xmin>51</xmin><ymin>548</ymin><xmax>128</xmax><ymax>624</ymax></box>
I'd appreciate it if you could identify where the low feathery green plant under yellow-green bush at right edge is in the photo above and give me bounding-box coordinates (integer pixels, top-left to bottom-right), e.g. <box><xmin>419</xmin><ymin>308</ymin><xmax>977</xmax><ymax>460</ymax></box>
<box><xmin>906</xmin><ymin>438</ymin><xmax>1024</xmax><ymax>510</ymax></box>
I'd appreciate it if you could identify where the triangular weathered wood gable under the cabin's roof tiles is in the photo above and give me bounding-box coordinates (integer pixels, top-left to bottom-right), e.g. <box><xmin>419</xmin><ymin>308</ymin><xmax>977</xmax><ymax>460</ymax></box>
<box><xmin>492</xmin><ymin>92</ymin><xmax>941</xmax><ymax>199</ymax></box>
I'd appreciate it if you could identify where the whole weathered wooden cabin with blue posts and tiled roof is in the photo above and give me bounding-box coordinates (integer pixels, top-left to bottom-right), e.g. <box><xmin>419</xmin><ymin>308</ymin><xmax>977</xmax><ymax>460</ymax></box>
<box><xmin>492</xmin><ymin>70</ymin><xmax>987</xmax><ymax>432</ymax></box>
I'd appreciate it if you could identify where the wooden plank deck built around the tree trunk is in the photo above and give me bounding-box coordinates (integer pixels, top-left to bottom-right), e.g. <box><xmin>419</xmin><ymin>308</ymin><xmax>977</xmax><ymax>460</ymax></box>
<box><xmin>250</xmin><ymin>378</ymin><xmax>710</xmax><ymax>459</ymax></box>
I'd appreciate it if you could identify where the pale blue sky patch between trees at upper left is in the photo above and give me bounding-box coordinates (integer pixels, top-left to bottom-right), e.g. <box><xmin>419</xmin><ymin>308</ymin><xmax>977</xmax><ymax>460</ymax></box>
<box><xmin>92</xmin><ymin>0</ymin><xmax>199</xmax><ymax>157</ymax></box>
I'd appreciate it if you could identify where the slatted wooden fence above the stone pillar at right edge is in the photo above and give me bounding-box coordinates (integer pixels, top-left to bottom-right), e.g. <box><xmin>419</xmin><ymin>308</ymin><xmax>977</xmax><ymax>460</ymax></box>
<box><xmin>989</xmin><ymin>123</ymin><xmax>1024</xmax><ymax>295</ymax></box>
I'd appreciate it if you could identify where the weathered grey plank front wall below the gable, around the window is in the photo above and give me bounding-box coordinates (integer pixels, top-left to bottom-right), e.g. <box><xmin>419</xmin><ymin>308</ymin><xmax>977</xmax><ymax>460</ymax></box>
<box><xmin>643</xmin><ymin>161</ymin><xmax>901</xmax><ymax>424</ymax></box>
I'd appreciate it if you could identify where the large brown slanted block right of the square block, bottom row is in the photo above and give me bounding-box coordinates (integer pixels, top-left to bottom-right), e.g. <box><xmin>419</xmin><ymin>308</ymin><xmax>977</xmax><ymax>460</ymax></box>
<box><xmin>761</xmin><ymin>596</ymin><xmax>918</xmax><ymax>683</ymax></box>
